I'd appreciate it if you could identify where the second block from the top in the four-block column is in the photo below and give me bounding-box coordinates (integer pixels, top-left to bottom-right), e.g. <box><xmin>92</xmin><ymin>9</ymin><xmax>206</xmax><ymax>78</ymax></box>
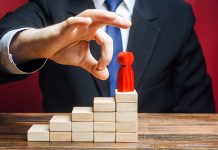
<box><xmin>94</xmin><ymin>112</ymin><xmax>115</xmax><ymax>122</ymax></box>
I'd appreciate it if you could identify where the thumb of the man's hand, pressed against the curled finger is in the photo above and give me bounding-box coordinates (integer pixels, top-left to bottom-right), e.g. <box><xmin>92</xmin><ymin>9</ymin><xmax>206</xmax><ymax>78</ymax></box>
<box><xmin>79</xmin><ymin>48</ymin><xmax>109</xmax><ymax>80</ymax></box>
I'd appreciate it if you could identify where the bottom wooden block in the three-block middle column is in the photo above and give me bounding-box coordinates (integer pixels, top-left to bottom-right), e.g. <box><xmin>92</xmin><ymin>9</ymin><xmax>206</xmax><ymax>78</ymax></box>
<box><xmin>72</xmin><ymin>132</ymin><xmax>94</xmax><ymax>142</ymax></box>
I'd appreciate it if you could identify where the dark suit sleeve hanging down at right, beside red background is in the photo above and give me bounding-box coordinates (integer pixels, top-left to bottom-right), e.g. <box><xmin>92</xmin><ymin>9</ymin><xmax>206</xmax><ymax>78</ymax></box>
<box><xmin>173</xmin><ymin>3</ymin><xmax>215</xmax><ymax>113</ymax></box>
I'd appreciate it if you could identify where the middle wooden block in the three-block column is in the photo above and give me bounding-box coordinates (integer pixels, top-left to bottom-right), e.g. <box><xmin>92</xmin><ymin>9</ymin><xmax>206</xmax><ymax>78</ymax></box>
<box><xmin>72</xmin><ymin>122</ymin><xmax>93</xmax><ymax>132</ymax></box>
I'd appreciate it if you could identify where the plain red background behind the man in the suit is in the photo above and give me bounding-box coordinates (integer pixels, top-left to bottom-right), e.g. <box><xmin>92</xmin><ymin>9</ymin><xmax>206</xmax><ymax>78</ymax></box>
<box><xmin>0</xmin><ymin>0</ymin><xmax>218</xmax><ymax>112</ymax></box>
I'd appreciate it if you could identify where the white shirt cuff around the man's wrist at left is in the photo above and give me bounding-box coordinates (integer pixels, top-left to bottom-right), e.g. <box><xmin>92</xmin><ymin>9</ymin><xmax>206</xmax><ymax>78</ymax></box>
<box><xmin>0</xmin><ymin>28</ymin><xmax>47</xmax><ymax>74</ymax></box>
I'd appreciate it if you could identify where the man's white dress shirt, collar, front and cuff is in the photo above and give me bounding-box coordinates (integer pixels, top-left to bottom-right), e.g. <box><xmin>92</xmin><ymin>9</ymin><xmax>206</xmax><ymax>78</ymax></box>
<box><xmin>0</xmin><ymin>0</ymin><xmax>135</xmax><ymax>74</ymax></box>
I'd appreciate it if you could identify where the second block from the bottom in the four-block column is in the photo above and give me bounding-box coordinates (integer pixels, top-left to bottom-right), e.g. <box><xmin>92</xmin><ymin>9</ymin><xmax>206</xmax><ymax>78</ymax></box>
<box><xmin>94</xmin><ymin>122</ymin><xmax>116</xmax><ymax>132</ymax></box>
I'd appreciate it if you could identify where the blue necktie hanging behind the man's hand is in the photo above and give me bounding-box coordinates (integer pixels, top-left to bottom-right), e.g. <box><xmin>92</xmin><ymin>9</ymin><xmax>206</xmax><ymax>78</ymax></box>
<box><xmin>105</xmin><ymin>0</ymin><xmax>123</xmax><ymax>97</ymax></box>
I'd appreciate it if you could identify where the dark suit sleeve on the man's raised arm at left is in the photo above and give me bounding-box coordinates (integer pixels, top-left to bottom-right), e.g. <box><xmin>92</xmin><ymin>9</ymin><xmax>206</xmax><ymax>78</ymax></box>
<box><xmin>0</xmin><ymin>0</ymin><xmax>49</xmax><ymax>84</ymax></box>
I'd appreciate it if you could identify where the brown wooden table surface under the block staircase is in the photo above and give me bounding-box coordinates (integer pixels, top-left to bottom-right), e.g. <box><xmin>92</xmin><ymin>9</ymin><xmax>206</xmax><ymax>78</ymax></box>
<box><xmin>0</xmin><ymin>113</ymin><xmax>218</xmax><ymax>149</ymax></box>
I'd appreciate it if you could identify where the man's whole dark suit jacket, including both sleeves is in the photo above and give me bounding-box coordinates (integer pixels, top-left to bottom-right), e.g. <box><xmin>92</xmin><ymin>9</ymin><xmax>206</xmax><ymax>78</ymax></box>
<box><xmin>0</xmin><ymin>0</ymin><xmax>214</xmax><ymax>112</ymax></box>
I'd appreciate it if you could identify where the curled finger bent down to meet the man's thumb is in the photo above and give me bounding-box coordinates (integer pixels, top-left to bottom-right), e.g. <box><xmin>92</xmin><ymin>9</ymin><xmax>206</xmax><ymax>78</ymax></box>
<box><xmin>95</xmin><ymin>29</ymin><xmax>113</xmax><ymax>70</ymax></box>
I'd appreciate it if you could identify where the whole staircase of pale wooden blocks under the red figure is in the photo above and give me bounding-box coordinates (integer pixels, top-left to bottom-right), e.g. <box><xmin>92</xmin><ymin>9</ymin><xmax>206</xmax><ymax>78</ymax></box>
<box><xmin>27</xmin><ymin>91</ymin><xmax>138</xmax><ymax>142</ymax></box>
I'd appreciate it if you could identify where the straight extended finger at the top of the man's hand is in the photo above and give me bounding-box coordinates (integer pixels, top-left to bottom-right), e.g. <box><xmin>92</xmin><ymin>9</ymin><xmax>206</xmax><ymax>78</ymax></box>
<box><xmin>78</xmin><ymin>9</ymin><xmax>132</xmax><ymax>28</ymax></box>
